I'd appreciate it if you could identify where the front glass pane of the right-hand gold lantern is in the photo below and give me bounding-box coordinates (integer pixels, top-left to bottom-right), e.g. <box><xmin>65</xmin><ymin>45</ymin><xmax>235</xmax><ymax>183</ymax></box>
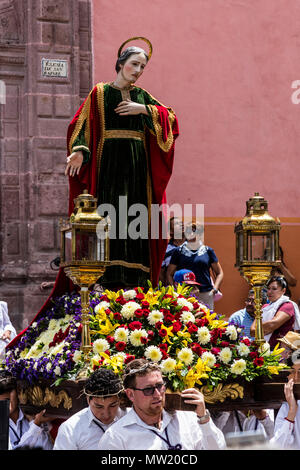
<box><xmin>248</xmin><ymin>233</ymin><xmax>275</xmax><ymax>261</ymax></box>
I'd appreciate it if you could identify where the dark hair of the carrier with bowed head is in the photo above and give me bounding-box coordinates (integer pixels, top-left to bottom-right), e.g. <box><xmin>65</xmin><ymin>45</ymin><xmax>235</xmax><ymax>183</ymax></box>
<box><xmin>84</xmin><ymin>368</ymin><xmax>123</xmax><ymax>398</ymax></box>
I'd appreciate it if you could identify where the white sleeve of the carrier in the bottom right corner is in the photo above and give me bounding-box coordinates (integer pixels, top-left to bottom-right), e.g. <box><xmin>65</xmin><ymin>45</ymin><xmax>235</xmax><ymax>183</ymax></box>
<box><xmin>270</xmin><ymin>403</ymin><xmax>294</xmax><ymax>449</ymax></box>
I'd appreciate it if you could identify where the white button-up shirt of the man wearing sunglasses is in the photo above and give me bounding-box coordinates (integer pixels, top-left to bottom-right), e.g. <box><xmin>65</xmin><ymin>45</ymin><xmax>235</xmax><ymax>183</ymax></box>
<box><xmin>98</xmin><ymin>409</ymin><xmax>225</xmax><ymax>450</ymax></box>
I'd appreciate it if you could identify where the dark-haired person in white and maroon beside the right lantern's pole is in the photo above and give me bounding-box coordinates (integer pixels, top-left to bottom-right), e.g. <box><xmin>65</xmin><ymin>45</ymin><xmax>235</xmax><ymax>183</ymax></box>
<box><xmin>250</xmin><ymin>276</ymin><xmax>299</xmax><ymax>349</ymax></box>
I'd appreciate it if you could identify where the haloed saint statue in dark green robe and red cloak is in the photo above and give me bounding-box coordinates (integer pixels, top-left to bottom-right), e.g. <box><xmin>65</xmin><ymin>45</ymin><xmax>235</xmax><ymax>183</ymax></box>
<box><xmin>66</xmin><ymin>38</ymin><xmax>178</xmax><ymax>288</ymax></box>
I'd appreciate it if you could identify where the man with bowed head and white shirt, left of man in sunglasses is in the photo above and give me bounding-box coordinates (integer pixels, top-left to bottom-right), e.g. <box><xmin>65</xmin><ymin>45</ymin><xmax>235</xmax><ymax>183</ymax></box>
<box><xmin>54</xmin><ymin>369</ymin><xmax>126</xmax><ymax>450</ymax></box>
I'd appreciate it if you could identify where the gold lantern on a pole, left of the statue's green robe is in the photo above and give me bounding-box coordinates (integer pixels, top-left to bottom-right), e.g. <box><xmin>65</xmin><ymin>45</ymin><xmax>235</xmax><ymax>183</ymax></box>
<box><xmin>60</xmin><ymin>190</ymin><xmax>110</xmax><ymax>378</ymax></box>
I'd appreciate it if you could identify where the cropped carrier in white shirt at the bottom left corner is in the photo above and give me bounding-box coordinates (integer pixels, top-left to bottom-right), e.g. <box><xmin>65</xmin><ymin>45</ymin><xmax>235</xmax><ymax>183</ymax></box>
<box><xmin>0</xmin><ymin>370</ymin><xmax>53</xmax><ymax>450</ymax></box>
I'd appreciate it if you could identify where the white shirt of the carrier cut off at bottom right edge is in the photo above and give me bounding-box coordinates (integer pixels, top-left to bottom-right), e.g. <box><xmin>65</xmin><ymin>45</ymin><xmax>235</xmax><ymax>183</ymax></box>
<box><xmin>270</xmin><ymin>400</ymin><xmax>300</xmax><ymax>450</ymax></box>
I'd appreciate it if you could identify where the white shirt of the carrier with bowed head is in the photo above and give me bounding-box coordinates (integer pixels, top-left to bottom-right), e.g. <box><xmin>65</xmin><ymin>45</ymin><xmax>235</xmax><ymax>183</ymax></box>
<box><xmin>53</xmin><ymin>407</ymin><xmax>126</xmax><ymax>450</ymax></box>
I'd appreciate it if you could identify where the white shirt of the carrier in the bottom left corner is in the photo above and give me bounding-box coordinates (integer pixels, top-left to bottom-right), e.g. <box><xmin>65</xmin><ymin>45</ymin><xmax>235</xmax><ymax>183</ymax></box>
<box><xmin>9</xmin><ymin>409</ymin><xmax>53</xmax><ymax>450</ymax></box>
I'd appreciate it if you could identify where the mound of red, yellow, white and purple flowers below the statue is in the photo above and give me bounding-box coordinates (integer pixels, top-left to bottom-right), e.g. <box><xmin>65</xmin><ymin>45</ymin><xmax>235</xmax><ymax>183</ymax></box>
<box><xmin>6</xmin><ymin>285</ymin><xmax>285</xmax><ymax>391</ymax></box>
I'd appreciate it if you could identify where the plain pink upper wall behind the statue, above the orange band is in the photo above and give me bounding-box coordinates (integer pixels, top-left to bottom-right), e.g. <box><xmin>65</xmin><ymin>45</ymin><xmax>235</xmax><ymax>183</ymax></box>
<box><xmin>93</xmin><ymin>0</ymin><xmax>300</xmax><ymax>218</ymax></box>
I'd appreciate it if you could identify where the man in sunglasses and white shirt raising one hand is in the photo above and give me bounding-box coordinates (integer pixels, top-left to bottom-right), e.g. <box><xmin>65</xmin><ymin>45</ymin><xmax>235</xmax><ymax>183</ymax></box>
<box><xmin>98</xmin><ymin>359</ymin><xmax>225</xmax><ymax>450</ymax></box>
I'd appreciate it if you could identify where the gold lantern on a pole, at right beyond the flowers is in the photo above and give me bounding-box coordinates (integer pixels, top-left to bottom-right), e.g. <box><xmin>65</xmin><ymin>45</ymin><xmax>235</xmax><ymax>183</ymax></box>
<box><xmin>234</xmin><ymin>193</ymin><xmax>280</xmax><ymax>345</ymax></box>
